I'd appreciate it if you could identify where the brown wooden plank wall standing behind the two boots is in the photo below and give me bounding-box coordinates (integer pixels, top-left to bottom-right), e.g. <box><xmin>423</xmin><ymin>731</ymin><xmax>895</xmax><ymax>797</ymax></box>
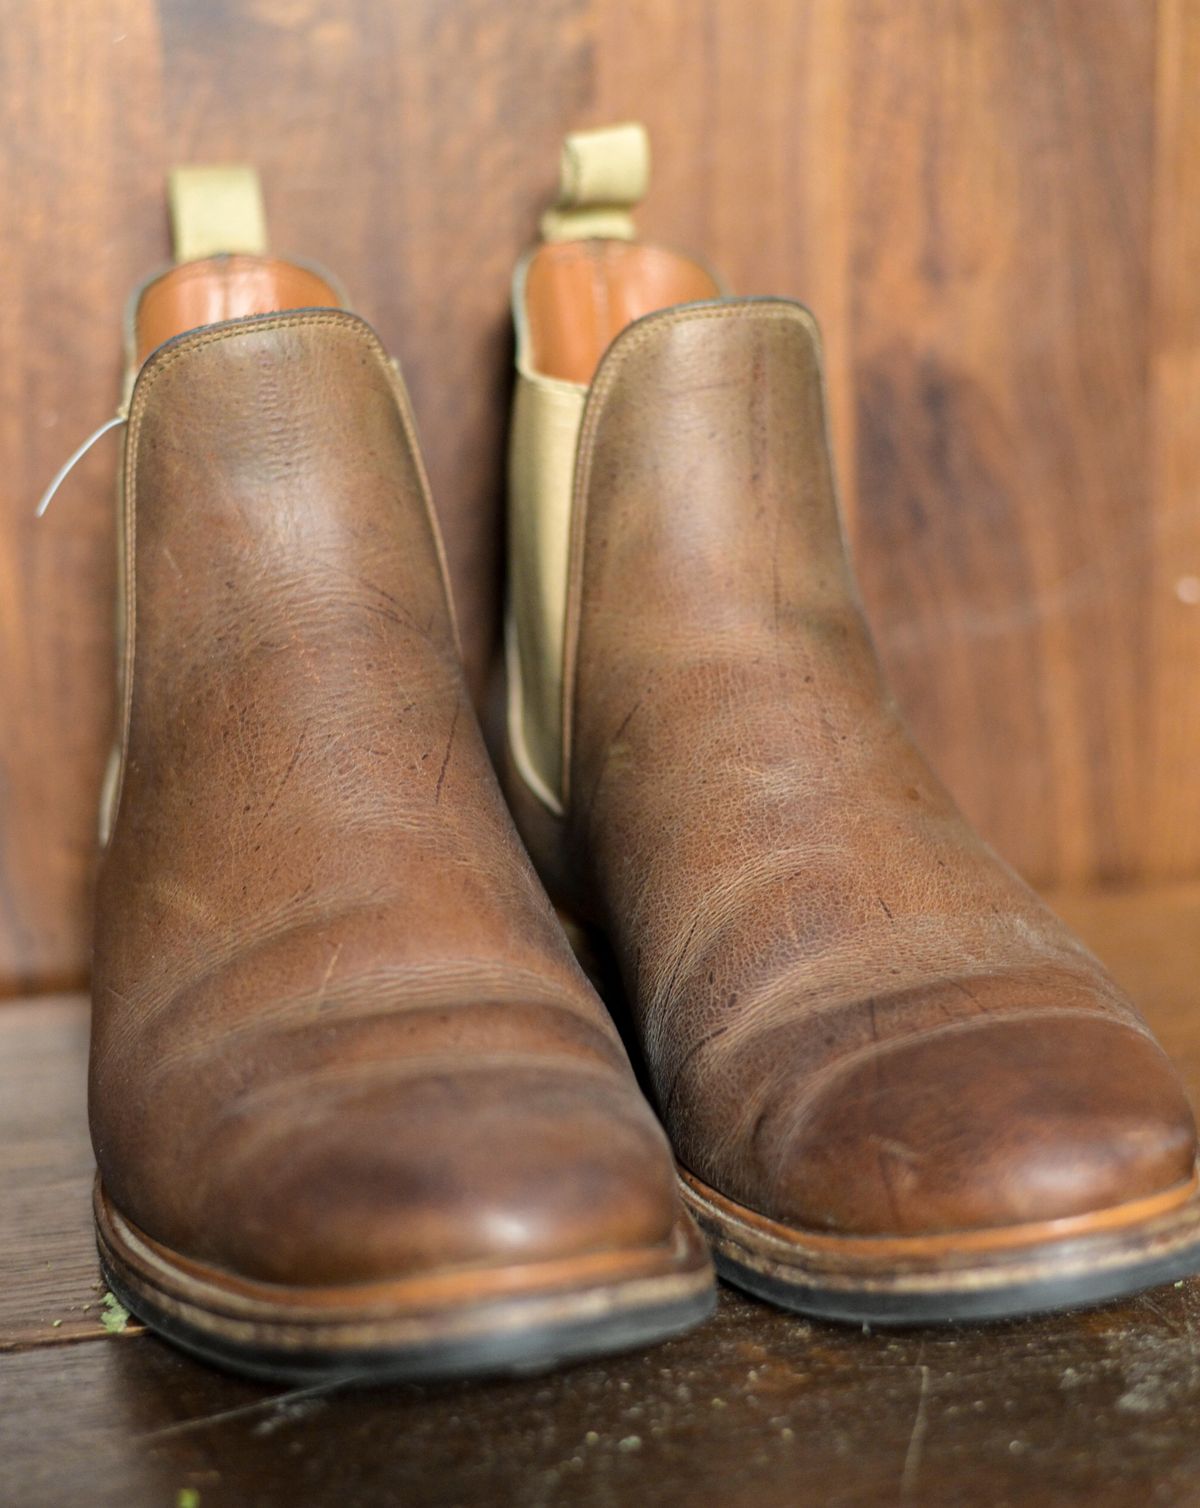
<box><xmin>0</xmin><ymin>0</ymin><xmax>1200</xmax><ymax>994</ymax></box>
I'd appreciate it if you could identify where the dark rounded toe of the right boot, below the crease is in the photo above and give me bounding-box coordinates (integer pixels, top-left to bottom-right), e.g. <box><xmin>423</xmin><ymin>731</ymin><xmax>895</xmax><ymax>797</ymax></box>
<box><xmin>755</xmin><ymin>1016</ymin><xmax>1195</xmax><ymax>1237</ymax></box>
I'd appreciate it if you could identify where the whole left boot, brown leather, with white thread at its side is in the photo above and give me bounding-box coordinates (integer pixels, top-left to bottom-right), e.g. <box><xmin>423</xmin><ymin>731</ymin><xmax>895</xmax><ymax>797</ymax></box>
<box><xmin>72</xmin><ymin>171</ymin><xmax>713</xmax><ymax>1378</ymax></box>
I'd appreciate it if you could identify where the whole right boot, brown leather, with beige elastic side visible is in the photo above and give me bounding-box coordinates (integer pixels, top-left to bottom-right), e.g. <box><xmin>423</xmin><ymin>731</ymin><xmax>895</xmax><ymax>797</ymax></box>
<box><xmin>507</xmin><ymin>127</ymin><xmax>1200</xmax><ymax>1323</ymax></box>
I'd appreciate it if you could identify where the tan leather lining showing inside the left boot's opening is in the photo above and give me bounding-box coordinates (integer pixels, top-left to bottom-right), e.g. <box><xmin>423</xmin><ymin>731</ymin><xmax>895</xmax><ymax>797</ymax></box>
<box><xmin>136</xmin><ymin>255</ymin><xmax>342</xmax><ymax>363</ymax></box>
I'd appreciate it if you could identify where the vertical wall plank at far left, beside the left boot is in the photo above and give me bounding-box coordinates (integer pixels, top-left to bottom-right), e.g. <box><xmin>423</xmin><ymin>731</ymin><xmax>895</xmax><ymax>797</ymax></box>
<box><xmin>0</xmin><ymin>0</ymin><xmax>161</xmax><ymax>994</ymax></box>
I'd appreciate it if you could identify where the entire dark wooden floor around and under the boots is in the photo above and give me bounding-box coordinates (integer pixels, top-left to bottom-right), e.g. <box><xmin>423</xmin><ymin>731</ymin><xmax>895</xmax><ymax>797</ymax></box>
<box><xmin>0</xmin><ymin>885</ymin><xmax>1200</xmax><ymax>1508</ymax></box>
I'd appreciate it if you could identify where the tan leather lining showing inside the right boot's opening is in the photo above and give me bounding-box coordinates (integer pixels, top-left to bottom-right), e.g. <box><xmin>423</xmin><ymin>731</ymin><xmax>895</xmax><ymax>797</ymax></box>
<box><xmin>525</xmin><ymin>240</ymin><xmax>721</xmax><ymax>383</ymax></box>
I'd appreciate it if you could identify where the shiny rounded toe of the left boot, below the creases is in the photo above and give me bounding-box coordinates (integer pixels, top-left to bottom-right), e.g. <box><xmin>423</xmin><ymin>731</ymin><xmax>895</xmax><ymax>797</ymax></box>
<box><xmin>188</xmin><ymin>1069</ymin><xmax>680</xmax><ymax>1286</ymax></box>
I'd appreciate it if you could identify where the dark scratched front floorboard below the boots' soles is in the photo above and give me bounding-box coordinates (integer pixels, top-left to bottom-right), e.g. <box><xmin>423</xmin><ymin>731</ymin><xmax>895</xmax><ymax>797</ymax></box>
<box><xmin>0</xmin><ymin>1283</ymin><xmax>1200</xmax><ymax>1508</ymax></box>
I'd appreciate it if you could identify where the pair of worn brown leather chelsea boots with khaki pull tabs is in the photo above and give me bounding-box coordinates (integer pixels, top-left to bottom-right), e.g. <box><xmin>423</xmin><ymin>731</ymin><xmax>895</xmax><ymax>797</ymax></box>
<box><xmin>70</xmin><ymin>127</ymin><xmax>1200</xmax><ymax>1377</ymax></box>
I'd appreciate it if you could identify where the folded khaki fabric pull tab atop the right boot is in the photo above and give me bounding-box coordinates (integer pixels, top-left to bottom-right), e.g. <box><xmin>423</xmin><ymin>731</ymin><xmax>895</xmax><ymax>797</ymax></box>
<box><xmin>541</xmin><ymin>121</ymin><xmax>650</xmax><ymax>241</ymax></box>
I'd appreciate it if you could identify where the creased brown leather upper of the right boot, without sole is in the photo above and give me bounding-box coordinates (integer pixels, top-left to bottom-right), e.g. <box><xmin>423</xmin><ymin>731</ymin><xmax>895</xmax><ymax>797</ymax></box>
<box><xmin>546</xmin><ymin>300</ymin><xmax>1195</xmax><ymax>1235</ymax></box>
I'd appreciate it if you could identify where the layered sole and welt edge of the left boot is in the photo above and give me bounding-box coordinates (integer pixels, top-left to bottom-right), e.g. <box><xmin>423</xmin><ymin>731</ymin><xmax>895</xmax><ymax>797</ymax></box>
<box><xmin>95</xmin><ymin>1181</ymin><xmax>716</xmax><ymax>1386</ymax></box>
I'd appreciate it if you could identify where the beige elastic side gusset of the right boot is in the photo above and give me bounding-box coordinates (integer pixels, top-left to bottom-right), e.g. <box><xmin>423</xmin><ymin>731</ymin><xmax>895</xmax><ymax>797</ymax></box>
<box><xmin>505</xmin><ymin>369</ymin><xmax>588</xmax><ymax>813</ymax></box>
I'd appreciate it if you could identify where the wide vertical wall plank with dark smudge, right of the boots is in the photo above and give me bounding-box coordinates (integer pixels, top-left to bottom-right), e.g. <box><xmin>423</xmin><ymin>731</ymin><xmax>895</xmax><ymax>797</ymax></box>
<box><xmin>850</xmin><ymin>0</ymin><xmax>1155</xmax><ymax>881</ymax></box>
